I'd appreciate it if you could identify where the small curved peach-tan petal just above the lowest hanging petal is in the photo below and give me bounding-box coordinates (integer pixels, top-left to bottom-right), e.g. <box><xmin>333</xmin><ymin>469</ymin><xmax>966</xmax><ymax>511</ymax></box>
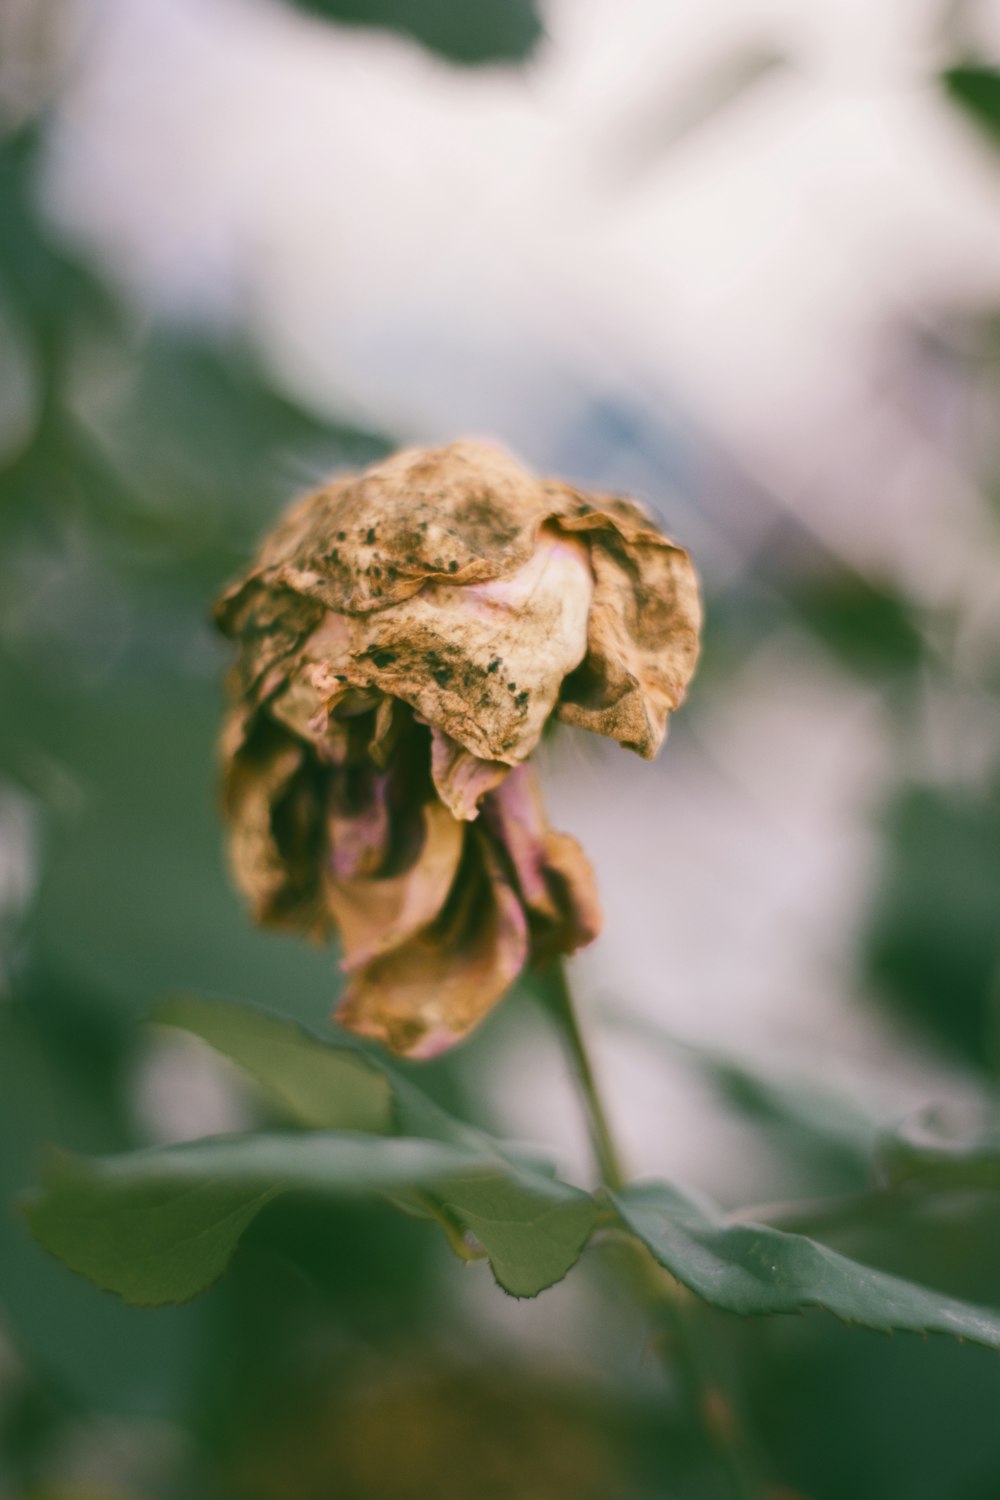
<box><xmin>325</xmin><ymin>803</ymin><xmax>465</xmax><ymax>971</ymax></box>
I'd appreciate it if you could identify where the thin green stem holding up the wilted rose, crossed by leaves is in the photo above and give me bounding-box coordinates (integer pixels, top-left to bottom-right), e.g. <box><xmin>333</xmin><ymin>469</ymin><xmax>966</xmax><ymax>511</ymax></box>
<box><xmin>546</xmin><ymin>960</ymin><xmax>768</xmax><ymax>1500</ymax></box>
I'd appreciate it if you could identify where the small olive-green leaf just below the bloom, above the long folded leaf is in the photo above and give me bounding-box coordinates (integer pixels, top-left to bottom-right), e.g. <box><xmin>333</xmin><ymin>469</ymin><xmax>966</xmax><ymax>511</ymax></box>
<box><xmin>154</xmin><ymin>996</ymin><xmax>393</xmax><ymax>1134</ymax></box>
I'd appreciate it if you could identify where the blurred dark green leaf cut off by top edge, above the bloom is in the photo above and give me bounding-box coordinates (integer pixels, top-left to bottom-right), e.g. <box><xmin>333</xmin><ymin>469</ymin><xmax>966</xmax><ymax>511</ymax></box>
<box><xmin>284</xmin><ymin>0</ymin><xmax>543</xmax><ymax>63</ymax></box>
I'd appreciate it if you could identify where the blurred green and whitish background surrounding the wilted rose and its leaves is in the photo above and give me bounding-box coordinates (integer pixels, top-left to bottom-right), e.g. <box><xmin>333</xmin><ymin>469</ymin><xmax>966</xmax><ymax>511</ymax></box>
<box><xmin>0</xmin><ymin>0</ymin><xmax>1000</xmax><ymax>1500</ymax></box>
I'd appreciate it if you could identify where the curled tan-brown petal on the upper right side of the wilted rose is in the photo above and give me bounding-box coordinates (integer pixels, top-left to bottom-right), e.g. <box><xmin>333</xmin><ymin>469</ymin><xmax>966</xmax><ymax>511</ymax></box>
<box><xmin>558</xmin><ymin>498</ymin><xmax>702</xmax><ymax>761</ymax></box>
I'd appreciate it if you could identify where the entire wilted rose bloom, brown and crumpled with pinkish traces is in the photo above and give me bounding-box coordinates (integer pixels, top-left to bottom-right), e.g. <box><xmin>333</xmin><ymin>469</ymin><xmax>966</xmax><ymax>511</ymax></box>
<box><xmin>217</xmin><ymin>443</ymin><xmax>700</xmax><ymax>1056</ymax></box>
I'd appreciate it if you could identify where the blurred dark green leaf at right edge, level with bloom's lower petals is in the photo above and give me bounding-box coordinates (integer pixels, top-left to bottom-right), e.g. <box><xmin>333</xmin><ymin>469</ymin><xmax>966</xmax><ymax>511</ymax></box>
<box><xmin>865</xmin><ymin>786</ymin><xmax>1000</xmax><ymax>1068</ymax></box>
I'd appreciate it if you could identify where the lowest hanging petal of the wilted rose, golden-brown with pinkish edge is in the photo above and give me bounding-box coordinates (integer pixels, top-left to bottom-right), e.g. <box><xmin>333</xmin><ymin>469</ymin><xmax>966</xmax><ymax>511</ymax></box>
<box><xmin>336</xmin><ymin>824</ymin><xmax>529</xmax><ymax>1058</ymax></box>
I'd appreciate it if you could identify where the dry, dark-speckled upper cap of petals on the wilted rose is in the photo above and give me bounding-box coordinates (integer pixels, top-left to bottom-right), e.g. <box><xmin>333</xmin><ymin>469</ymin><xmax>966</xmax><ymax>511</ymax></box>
<box><xmin>217</xmin><ymin>443</ymin><xmax>700</xmax><ymax>765</ymax></box>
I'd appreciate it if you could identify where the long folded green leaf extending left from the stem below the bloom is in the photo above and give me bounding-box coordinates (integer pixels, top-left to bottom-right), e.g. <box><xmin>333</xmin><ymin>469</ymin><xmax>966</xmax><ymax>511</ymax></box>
<box><xmin>25</xmin><ymin>1131</ymin><xmax>597</xmax><ymax>1305</ymax></box>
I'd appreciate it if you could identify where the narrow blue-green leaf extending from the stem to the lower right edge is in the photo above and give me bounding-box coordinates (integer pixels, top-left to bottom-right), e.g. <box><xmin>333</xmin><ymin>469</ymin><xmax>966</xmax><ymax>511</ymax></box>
<box><xmin>613</xmin><ymin>1182</ymin><xmax>1000</xmax><ymax>1349</ymax></box>
